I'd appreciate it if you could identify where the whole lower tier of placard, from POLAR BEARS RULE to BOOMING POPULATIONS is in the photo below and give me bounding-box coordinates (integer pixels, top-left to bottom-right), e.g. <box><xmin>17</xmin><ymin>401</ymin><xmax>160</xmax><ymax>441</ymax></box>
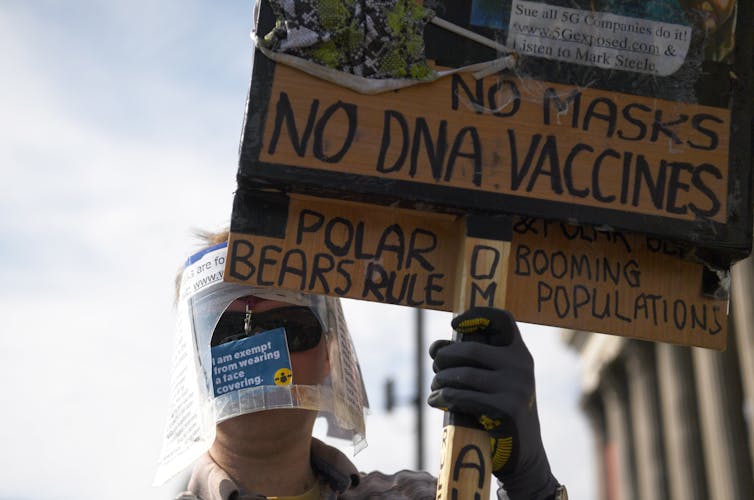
<box><xmin>224</xmin><ymin>192</ymin><xmax>727</xmax><ymax>349</ymax></box>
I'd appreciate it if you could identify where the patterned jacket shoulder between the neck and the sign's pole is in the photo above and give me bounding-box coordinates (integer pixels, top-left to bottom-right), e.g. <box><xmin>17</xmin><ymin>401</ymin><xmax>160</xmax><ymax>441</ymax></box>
<box><xmin>343</xmin><ymin>470</ymin><xmax>437</xmax><ymax>500</ymax></box>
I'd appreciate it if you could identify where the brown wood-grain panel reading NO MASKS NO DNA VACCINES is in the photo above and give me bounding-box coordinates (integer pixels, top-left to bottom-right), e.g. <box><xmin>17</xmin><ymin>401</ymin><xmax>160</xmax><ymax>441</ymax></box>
<box><xmin>259</xmin><ymin>67</ymin><xmax>730</xmax><ymax>222</ymax></box>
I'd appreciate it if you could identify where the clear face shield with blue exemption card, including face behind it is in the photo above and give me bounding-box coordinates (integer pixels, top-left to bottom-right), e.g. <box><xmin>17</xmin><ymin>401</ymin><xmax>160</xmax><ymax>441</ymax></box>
<box><xmin>155</xmin><ymin>243</ymin><xmax>368</xmax><ymax>485</ymax></box>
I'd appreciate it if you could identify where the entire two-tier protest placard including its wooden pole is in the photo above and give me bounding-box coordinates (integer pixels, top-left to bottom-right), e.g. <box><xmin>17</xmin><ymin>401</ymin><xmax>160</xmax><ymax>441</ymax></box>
<box><xmin>229</xmin><ymin>0</ymin><xmax>754</xmax><ymax>492</ymax></box>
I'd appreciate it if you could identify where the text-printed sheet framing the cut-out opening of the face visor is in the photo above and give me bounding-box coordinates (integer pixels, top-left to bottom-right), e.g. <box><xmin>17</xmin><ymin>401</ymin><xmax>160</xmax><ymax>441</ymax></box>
<box><xmin>154</xmin><ymin>243</ymin><xmax>368</xmax><ymax>485</ymax></box>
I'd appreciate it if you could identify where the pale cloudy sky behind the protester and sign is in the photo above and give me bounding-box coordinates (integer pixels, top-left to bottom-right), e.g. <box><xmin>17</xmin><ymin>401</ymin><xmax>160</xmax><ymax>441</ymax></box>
<box><xmin>0</xmin><ymin>0</ymin><xmax>595</xmax><ymax>500</ymax></box>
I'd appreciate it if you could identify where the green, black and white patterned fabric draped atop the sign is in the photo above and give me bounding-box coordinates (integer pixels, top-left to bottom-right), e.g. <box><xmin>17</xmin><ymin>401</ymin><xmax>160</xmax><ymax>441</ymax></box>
<box><xmin>262</xmin><ymin>0</ymin><xmax>434</xmax><ymax>80</ymax></box>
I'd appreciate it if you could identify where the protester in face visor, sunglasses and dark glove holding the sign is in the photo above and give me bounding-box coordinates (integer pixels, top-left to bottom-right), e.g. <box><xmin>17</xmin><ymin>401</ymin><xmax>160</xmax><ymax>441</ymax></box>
<box><xmin>156</xmin><ymin>232</ymin><xmax>567</xmax><ymax>500</ymax></box>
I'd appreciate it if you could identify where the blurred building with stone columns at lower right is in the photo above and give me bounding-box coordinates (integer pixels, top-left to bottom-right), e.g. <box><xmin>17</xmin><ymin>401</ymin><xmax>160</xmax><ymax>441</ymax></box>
<box><xmin>566</xmin><ymin>258</ymin><xmax>754</xmax><ymax>500</ymax></box>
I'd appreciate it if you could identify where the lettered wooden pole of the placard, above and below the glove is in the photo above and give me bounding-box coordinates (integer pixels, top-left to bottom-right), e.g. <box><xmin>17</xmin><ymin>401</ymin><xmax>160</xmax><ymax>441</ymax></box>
<box><xmin>436</xmin><ymin>214</ymin><xmax>512</xmax><ymax>500</ymax></box>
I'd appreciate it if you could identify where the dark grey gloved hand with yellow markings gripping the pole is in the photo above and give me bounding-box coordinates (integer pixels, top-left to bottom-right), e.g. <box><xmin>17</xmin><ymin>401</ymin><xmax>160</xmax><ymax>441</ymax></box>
<box><xmin>428</xmin><ymin>307</ymin><xmax>558</xmax><ymax>500</ymax></box>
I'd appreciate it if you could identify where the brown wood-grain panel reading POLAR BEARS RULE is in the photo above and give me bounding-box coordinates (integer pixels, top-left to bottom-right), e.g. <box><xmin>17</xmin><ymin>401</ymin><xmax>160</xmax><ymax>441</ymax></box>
<box><xmin>225</xmin><ymin>191</ymin><xmax>461</xmax><ymax>310</ymax></box>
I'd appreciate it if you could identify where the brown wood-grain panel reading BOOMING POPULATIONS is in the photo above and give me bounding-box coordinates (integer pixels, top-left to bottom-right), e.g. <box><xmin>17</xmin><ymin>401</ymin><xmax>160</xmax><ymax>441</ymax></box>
<box><xmin>508</xmin><ymin>218</ymin><xmax>728</xmax><ymax>349</ymax></box>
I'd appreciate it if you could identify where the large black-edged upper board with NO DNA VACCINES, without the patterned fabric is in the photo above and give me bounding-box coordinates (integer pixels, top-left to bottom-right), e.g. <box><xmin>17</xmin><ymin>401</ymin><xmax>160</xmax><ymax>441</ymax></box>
<box><xmin>239</xmin><ymin>0</ymin><xmax>754</xmax><ymax>269</ymax></box>
